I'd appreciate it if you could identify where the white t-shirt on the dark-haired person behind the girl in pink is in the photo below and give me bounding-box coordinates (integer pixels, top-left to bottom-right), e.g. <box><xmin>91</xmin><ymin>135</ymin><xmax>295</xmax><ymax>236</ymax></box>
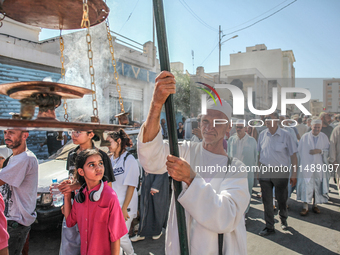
<box><xmin>110</xmin><ymin>152</ymin><xmax>139</xmax><ymax>218</ymax></box>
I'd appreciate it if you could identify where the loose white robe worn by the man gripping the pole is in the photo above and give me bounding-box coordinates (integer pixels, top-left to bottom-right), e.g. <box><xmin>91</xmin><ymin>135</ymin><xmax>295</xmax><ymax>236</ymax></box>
<box><xmin>137</xmin><ymin>126</ymin><xmax>249</xmax><ymax>255</ymax></box>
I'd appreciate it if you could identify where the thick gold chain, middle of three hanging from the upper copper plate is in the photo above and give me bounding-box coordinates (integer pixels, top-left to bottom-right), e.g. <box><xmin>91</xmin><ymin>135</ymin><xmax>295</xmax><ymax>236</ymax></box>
<box><xmin>81</xmin><ymin>0</ymin><xmax>98</xmax><ymax>117</ymax></box>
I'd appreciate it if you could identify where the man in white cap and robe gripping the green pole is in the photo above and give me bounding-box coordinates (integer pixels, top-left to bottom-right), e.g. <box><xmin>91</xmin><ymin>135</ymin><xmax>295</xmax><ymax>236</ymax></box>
<box><xmin>138</xmin><ymin>71</ymin><xmax>249</xmax><ymax>255</ymax></box>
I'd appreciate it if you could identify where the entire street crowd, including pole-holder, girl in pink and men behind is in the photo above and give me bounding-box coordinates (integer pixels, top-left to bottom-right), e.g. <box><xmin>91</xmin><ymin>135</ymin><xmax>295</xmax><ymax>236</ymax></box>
<box><xmin>0</xmin><ymin>72</ymin><xmax>340</xmax><ymax>255</ymax></box>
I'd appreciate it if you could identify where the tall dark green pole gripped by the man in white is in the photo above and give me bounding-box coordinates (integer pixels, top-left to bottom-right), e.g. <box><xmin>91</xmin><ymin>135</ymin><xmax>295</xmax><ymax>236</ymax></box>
<box><xmin>153</xmin><ymin>0</ymin><xmax>189</xmax><ymax>255</ymax></box>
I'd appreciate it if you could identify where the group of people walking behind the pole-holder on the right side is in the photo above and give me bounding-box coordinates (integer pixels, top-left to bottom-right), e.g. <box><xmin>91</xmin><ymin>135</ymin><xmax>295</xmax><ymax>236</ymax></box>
<box><xmin>186</xmin><ymin>107</ymin><xmax>340</xmax><ymax>236</ymax></box>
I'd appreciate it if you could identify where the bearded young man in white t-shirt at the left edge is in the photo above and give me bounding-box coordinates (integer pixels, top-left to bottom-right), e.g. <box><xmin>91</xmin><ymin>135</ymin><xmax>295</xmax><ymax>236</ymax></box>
<box><xmin>0</xmin><ymin>129</ymin><xmax>38</xmax><ymax>255</ymax></box>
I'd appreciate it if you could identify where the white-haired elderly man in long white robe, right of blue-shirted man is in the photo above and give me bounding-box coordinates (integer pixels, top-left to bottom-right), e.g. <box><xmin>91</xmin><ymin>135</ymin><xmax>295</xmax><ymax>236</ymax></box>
<box><xmin>296</xmin><ymin>119</ymin><xmax>329</xmax><ymax>216</ymax></box>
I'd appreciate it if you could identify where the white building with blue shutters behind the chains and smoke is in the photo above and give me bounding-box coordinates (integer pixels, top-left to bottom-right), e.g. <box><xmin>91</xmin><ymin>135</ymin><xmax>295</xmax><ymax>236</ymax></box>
<box><xmin>0</xmin><ymin>17</ymin><xmax>159</xmax><ymax>158</ymax></box>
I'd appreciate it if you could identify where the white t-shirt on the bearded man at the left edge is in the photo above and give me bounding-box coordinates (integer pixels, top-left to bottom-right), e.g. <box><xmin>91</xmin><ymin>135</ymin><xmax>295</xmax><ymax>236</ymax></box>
<box><xmin>0</xmin><ymin>150</ymin><xmax>38</xmax><ymax>226</ymax></box>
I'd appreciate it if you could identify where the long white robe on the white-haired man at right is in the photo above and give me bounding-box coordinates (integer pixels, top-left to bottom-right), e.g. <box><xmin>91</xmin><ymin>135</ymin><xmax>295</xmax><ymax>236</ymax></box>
<box><xmin>296</xmin><ymin>131</ymin><xmax>329</xmax><ymax>204</ymax></box>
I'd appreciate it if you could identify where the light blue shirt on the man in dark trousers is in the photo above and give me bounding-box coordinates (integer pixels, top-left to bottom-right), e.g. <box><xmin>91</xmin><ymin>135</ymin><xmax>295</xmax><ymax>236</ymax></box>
<box><xmin>257</xmin><ymin>127</ymin><xmax>297</xmax><ymax>166</ymax></box>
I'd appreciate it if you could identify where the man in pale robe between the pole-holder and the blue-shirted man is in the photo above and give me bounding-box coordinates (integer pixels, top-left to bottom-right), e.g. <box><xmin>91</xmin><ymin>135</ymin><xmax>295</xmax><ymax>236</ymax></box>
<box><xmin>228</xmin><ymin>120</ymin><xmax>257</xmax><ymax>213</ymax></box>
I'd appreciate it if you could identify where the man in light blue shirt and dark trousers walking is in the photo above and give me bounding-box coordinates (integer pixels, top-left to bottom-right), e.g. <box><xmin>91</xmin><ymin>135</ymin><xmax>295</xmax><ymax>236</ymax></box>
<box><xmin>257</xmin><ymin>113</ymin><xmax>297</xmax><ymax>236</ymax></box>
